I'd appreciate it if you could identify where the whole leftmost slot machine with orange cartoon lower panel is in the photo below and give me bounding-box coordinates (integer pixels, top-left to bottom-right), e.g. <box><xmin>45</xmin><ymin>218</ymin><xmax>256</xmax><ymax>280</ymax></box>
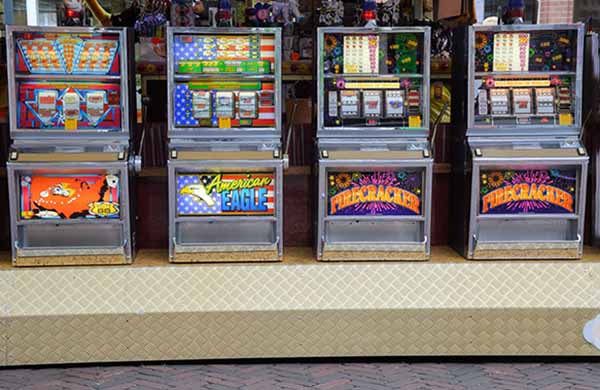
<box><xmin>7</xmin><ymin>26</ymin><xmax>140</xmax><ymax>266</ymax></box>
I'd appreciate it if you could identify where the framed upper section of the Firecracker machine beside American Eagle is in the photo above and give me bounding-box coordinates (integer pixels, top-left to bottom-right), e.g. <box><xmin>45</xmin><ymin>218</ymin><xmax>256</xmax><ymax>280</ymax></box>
<box><xmin>318</xmin><ymin>28</ymin><xmax>430</xmax><ymax>138</ymax></box>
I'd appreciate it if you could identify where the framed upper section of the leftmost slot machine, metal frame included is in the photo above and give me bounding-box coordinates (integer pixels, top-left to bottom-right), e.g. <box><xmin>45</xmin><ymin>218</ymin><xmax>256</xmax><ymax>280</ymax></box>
<box><xmin>7</xmin><ymin>26</ymin><xmax>130</xmax><ymax>142</ymax></box>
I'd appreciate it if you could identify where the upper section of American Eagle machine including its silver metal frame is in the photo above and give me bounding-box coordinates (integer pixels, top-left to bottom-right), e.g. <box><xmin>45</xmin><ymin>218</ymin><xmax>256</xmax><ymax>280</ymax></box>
<box><xmin>168</xmin><ymin>28</ymin><xmax>281</xmax><ymax>140</ymax></box>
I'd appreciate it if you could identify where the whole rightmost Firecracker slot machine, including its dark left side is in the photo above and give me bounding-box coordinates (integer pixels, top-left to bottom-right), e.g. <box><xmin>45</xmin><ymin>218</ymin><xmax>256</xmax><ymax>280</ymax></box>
<box><xmin>453</xmin><ymin>24</ymin><xmax>588</xmax><ymax>259</ymax></box>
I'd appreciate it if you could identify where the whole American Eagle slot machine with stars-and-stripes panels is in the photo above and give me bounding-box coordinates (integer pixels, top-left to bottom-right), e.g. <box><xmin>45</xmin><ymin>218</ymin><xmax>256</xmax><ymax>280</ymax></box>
<box><xmin>167</xmin><ymin>28</ymin><xmax>286</xmax><ymax>262</ymax></box>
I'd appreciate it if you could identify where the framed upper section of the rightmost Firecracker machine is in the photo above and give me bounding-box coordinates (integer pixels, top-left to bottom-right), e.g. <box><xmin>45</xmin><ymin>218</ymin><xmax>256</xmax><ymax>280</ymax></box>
<box><xmin>469</xmin><ymin>24</ymin><xmax>583</xmax><ymax>136</ymax></box>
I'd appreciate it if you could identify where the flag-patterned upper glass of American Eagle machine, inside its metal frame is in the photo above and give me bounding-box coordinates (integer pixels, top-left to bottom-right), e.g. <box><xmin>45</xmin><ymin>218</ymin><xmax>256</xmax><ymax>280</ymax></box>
<box><xmin>173</xmin><ymin>34</ymin><xmax>276</xmax><ymax>129</ymax></box>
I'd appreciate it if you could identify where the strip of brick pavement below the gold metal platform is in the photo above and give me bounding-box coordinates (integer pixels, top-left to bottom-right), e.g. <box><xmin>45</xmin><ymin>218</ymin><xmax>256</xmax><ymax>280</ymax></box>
<box><xmin>0</xmin><ymin>362</ymin><xmax>600</xmax><ymax>390</ymax></box>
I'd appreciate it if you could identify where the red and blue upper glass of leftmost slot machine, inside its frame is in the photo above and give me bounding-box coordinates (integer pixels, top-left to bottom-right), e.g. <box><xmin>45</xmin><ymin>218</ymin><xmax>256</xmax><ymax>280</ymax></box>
<box><xmin>14</xmin><ymin>32</ymin><xmax>123</xmax><ymax>132</ymax></box>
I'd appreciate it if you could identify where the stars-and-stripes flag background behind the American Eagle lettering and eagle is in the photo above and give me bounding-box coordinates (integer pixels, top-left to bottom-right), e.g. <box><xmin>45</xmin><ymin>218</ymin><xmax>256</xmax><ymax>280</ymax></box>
<box><xmin>177</xmin><ymin>173</ymin><xmax>275</xmax><ymax>216</ymax></box>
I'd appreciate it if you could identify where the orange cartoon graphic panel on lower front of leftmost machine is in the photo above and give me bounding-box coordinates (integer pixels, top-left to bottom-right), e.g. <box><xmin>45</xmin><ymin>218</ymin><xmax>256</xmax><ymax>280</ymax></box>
<box><xmin>20</xmin><ymin>174</ymin><xmax>120</xmax><ymax>219</ymax></box>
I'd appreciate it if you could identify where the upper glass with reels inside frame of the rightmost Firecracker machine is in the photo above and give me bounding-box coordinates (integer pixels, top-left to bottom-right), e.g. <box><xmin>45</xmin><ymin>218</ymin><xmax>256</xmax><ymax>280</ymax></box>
<box><xmin>473</xmin><ymin>30</ymin><xmax>577</xmax><ymax>127</ymax></box>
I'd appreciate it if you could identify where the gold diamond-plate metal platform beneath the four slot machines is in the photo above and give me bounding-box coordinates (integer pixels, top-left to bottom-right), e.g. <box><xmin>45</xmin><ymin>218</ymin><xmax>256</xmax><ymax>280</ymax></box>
<box><xmin>0</xmin><ymin>247</ymin><xmax>600</xmax><ymax>366</ymax></box>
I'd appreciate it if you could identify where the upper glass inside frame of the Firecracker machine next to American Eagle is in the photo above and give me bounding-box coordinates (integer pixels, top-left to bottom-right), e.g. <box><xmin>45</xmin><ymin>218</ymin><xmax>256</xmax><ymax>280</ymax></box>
<box><xmin>322</xmin><ymin>33</ymin><xmax>424</xmax><ymax>128</ymax></box>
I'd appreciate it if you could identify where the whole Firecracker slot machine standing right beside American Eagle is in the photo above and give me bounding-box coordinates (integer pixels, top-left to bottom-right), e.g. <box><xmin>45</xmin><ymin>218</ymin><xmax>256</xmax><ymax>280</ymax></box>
<box><xmin>316</xmin><ymin>27</ymin><xmax>433</xmax><ymax>261</ymax></box>
